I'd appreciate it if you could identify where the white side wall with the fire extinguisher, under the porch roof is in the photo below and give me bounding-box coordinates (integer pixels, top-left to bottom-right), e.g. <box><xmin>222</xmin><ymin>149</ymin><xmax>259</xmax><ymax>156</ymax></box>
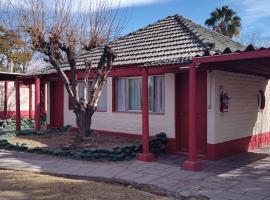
<box><xmin>207</xmin><ymin>70</ymin><xmax>270</xmax><ymax>144</ymax></box>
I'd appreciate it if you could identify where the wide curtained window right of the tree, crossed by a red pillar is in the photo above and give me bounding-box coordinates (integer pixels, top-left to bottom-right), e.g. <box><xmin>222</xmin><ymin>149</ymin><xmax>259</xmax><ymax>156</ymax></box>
<box><xmin>116</xmin><ymin>76</ymin><xmax>165</xmax><ymax>113</ymax></box>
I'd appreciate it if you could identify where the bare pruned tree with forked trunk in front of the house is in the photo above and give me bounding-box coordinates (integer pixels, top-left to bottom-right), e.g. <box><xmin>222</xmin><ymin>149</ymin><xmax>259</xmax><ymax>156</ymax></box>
<box><xmin>1</xmin><ymin>0</ymin><xmax>123</xmax><ymax>138</ymax></box>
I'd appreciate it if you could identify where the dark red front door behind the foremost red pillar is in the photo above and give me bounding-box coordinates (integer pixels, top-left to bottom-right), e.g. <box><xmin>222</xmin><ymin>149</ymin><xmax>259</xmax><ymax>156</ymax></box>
<box><xmin>175</xmin><ymin>72</ymin><xmax>207</xmax><ymax>154</ymax></box>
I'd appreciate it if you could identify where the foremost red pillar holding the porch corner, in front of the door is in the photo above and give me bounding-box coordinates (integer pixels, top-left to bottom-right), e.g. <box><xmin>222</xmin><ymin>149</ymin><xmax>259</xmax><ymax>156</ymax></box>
<box><xmin>183</xmin><ymin>63</ymin><xmax>202</xmax><ymax>171</ymax></box>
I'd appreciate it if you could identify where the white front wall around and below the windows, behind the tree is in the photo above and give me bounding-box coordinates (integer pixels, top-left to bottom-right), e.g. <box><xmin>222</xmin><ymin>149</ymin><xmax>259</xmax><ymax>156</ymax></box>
<box><xmin>64</xmin><ymin>74</ymin><xmax>175</xmax><ymax>138</ymax></box>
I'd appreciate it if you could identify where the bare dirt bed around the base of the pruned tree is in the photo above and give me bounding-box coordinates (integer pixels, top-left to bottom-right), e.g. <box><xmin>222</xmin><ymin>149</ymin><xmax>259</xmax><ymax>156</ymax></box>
<box><xmin>9</xmin><ymin>132</ymin><xmax>135</xmax><ymax>150</ymax></box>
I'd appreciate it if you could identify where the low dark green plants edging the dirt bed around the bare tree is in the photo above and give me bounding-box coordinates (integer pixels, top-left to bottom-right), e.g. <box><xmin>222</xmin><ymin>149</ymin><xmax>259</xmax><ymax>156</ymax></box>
<box><xmin>0</xmin><ymin>130</ymin><xmax>168</xmax><ymax>161</ymax></box>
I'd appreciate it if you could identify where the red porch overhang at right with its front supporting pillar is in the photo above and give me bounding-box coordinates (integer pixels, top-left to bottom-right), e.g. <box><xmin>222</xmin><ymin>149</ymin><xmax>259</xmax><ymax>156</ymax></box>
<box><xmin>183</xmin><ymin>45</ymin><xmax>270</xmax><ymax>171</ymax></box>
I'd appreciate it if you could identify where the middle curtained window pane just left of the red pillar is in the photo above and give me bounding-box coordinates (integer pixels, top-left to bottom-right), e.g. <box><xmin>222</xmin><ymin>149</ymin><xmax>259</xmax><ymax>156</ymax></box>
<box><xmin>129</xmin><ymin>79</ymin><xmax>142</xmax><ymax>110</ymax></box>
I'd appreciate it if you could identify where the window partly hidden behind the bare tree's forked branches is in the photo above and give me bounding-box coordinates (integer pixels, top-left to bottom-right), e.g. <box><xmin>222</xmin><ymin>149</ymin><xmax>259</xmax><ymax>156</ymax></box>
<box><xmin>69</xmin><ymin>80</ymin><xmax>107</xmax><ymax>111</ymax></box>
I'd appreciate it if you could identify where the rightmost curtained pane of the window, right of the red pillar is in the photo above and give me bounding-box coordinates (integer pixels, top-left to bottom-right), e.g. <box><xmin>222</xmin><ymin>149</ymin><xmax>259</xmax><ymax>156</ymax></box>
<box><xmin>155</xmin><ymin>76</ymin><xmax>165</xmax><ymax>112</ymax></box>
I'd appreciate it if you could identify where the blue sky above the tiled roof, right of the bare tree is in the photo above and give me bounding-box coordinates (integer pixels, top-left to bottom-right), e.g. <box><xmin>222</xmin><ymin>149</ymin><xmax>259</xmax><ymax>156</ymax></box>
<box><xmin>115</xmin><ymin>0</ymin><xmax>270</xmax><ymax>42</ymax></box>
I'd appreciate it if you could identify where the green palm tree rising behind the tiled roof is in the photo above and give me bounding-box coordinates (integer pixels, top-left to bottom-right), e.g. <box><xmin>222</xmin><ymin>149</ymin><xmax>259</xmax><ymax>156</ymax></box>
<box><xmin>204</xmin><ymin>6</ymin><xmax>241</xmax><ymax>38</ymax></box>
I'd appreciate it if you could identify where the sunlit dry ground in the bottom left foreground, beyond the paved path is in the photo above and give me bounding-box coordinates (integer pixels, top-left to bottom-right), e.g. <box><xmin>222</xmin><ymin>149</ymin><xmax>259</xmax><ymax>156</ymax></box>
<box><xmin>0</xmin><ymin>169</ymin><xmax>170</xmax><ymax>200</ymax></box>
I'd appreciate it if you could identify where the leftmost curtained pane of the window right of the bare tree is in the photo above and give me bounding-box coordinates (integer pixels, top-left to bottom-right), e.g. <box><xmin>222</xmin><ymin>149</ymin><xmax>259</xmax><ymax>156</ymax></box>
<box><xmin>116</xmin><ymin>79</ymin><xmax>127</xmax><ymax>111</ymax></box>
